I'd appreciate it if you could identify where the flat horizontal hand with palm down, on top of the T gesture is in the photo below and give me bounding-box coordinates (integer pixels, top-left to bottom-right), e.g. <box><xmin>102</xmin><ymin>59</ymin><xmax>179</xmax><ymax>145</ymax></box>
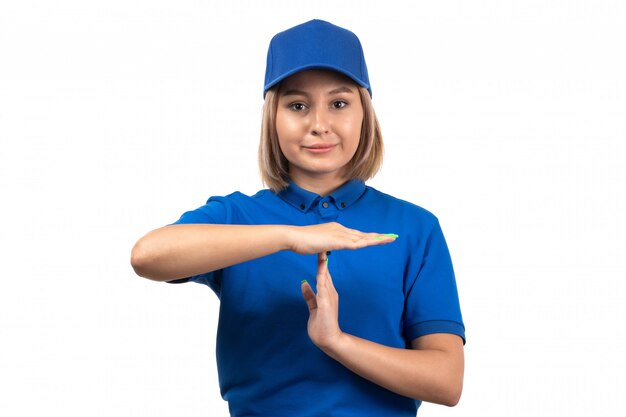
<box><xmin>287</xmin><ymin>222</ymin><xmax>398</xmax><ymax>255</ymax></box>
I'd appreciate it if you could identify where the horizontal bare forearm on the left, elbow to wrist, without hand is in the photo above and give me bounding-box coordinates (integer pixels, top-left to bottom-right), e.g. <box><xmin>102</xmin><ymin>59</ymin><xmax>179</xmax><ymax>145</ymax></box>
<box><xmin>131</xmin><ymin>224</ymin><xmax>289</xmax><ymax>281</ymax></box>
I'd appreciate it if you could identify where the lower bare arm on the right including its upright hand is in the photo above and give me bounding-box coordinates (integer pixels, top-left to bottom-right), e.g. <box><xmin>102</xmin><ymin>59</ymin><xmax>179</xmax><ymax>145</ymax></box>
<box><xmin>302</xmin><ymin>254</ymin><xmax>464</xmax><ymax>406</ymax></box>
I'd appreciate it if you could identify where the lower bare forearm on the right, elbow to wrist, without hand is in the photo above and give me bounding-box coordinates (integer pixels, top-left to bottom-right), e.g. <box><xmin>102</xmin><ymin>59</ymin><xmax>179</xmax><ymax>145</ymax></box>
<box><xmin>322</xmin><ymin>333</ymin><xmax>463</xmax><ymax>406</ymax></box>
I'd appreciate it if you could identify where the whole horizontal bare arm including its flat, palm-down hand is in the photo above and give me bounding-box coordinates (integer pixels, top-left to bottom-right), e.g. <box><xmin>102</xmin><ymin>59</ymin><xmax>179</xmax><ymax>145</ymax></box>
<box><xmin>131</xmin><ymin>223</ymin><xmax>395</xmax><ymax>281</ymax></box>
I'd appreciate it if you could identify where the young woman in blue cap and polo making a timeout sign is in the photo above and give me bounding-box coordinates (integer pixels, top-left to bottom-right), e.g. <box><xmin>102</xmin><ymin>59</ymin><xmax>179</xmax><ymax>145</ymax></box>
<box><xmin>131</xmin><ymin>20</ymin><xmax>465</xmax><ymax>417</ymax></box>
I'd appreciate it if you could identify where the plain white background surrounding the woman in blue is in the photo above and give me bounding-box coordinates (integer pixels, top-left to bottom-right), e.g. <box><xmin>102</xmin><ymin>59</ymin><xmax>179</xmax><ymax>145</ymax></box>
<box><xmin>0</xmin><ymin>0</ymin><xmax>626</xmax><ymax>417</ymax></box>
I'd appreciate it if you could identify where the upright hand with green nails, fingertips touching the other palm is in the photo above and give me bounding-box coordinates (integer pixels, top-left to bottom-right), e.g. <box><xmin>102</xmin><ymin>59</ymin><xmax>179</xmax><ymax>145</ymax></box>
<box><xmin>301</xmin><ymin>252</ymin><xmax>342</xmax><ymax>350</ymax></box>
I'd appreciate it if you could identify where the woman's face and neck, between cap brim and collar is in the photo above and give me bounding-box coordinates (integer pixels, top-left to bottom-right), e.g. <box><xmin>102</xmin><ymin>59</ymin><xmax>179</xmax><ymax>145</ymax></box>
<box><xmin>276</xmin><ymin>70</ymin><xmax>363</xmax><ymax>186</ymax></box>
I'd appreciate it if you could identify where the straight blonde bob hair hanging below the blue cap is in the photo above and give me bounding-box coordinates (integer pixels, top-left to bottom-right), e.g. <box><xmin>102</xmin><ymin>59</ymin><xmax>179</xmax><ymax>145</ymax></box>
<box><xmin>259</xmin><ymin>86</ymin><xmax>383</xmax><ymax>192</ymax></box>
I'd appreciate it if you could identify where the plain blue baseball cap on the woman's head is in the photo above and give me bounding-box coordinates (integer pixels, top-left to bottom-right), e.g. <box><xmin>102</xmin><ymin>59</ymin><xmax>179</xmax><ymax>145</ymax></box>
<box><xmin>263</xmin><ymin>19</ymin><xmax>372</xmax><ymax>97</ymax></box>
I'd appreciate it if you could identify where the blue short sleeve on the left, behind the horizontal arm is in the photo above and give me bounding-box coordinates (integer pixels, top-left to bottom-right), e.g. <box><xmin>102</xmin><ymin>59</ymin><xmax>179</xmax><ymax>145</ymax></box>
<box><xmin>167</xmin><ymin>197</ymin><xmax>230</xmax><ymax>297</ymax></box>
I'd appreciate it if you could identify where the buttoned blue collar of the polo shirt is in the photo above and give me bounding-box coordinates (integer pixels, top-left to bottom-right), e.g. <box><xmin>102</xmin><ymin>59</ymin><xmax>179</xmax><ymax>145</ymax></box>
<box><xmin>278</xmin><ymin>180</ymin><xmax>366</xmax><ymax>212</ymax></box>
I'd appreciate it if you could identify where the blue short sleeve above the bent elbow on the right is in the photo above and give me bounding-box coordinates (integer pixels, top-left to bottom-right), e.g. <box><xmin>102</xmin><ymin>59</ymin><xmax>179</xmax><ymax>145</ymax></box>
<box><xmin>404</xmin><ymin>220</ymin><xmax>465</xmax><ymax>343</ymax></box>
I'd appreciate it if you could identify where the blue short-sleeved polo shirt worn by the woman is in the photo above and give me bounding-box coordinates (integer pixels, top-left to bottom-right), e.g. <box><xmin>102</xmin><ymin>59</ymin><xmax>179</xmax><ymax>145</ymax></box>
<box><xmin>168</xmin><ymin>180</ymin><xmax>465</xmax><ymax>417</ymax></box>
